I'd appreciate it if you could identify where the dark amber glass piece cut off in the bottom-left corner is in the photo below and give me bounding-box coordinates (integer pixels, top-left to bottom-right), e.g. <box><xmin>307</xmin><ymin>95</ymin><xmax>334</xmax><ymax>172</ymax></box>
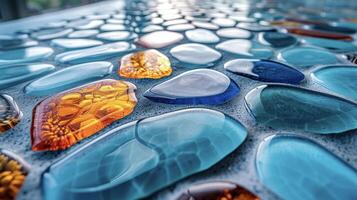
<box><xmin>0</xmin><ymin>149</ymin><xmax>29</xmax><ymax>200</ymax></box>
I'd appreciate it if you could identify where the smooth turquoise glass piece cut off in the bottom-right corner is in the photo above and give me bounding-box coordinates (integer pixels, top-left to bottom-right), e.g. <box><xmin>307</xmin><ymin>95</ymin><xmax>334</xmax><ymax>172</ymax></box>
<box><xmin>256</xmin><ymin>135</ymin><xmax>357</xmax><ymax>200</ymax></box>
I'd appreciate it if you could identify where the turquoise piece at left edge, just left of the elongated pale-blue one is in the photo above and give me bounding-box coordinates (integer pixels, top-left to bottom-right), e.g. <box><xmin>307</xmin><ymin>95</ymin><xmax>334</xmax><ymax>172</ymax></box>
<box><xmin>0</xmin><ymin>64</ymin><xmax>55</xmax><ymax>89</ymax></box>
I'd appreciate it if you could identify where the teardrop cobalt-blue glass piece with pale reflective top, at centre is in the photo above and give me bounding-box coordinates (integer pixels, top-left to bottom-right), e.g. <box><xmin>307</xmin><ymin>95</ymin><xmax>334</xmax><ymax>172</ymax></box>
<box><xmin>144</xmin><ymin>69</ymin><xmax>240</xmax><ymax>105</ymax></box>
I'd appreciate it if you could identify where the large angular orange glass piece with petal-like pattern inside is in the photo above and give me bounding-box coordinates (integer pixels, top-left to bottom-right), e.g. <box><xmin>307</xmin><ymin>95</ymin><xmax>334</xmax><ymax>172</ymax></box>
<box><xmin>31</xmin><ymin>79</ymin><xmax>137</xmax><ymax>151</ymax></box>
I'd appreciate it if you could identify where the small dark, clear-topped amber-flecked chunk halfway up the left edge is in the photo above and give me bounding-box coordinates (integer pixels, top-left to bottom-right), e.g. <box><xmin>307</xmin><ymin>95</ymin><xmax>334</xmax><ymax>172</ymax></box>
<box><xmin>0</xmin><ymin>94</ymin><xmax>22</xmax><ymax>133</ymax></box>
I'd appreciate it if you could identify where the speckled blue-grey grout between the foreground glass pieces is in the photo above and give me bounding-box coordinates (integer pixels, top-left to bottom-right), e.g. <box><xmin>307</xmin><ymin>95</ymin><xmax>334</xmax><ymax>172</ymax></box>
<box><xmin>0</xmin><ymin>0</ymin><xmax>357</xmax><ymax>200</ymax></box>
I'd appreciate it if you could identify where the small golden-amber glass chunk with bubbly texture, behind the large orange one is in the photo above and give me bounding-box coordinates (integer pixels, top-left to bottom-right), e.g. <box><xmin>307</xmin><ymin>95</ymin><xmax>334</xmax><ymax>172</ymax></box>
<box><xmin>118</xmin><ymin>49</ymin><xmax>172</xmax><ymax>79</ymax></box>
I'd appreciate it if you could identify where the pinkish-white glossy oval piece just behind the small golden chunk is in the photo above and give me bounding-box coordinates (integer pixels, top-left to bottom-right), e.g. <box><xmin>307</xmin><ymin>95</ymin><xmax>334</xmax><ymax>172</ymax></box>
<box><xmin>138</xmin><ymin>31</ymin><xmax>183</xmax><ymax>49</ymax></box>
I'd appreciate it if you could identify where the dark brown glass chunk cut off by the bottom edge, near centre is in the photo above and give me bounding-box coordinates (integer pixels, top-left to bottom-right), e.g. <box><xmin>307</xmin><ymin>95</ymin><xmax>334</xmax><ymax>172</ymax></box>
<box><xmin>177</xmin><ymin>181</ymin><xmax>260</xmax><ymax>200</ymax></box>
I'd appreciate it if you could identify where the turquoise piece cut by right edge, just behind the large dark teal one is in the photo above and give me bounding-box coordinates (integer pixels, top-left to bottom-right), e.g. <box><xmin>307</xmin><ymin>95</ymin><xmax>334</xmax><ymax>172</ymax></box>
<box><xmin>311</xmin><ymin>65</ymin><xmax>357</xmax><ymax>99</ymax></box>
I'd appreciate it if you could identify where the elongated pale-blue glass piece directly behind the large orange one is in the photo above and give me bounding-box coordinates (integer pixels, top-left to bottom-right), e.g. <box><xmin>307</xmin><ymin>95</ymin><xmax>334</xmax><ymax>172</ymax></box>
<box><xmin>24</xmin><ymin>62</ymin><xmax>113</xmax><ymax>96</ymax></box>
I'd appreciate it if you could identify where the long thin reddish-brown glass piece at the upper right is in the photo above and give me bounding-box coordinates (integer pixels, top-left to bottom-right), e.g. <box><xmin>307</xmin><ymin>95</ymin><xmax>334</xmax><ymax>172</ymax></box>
<box><xmin>287</xmin><ymin>28</ymin><xmax>353</xmax><ymax>40</ymax></box>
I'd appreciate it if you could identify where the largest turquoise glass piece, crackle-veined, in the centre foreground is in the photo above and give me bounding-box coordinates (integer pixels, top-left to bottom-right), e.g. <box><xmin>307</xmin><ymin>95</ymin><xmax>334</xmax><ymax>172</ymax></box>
<box><xmin>42</xmin><ymin>108</ymin><xmax>247</xmax><ymax>200</ymax></box>
